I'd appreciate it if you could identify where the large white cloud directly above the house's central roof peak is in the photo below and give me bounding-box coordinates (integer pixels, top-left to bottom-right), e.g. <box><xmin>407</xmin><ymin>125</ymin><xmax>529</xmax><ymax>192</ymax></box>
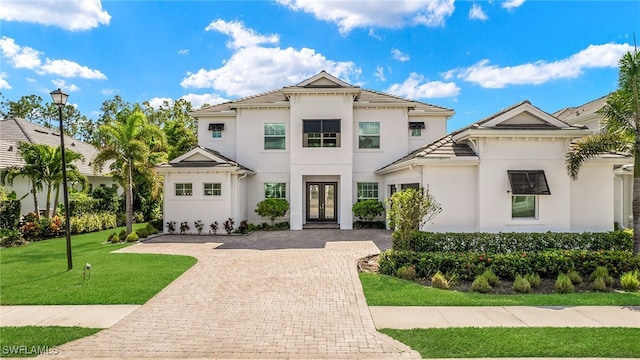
<box><xmin>180</xmin><ymin>23</ymin><xmax>361</xmax><ymax>96</ymax></box>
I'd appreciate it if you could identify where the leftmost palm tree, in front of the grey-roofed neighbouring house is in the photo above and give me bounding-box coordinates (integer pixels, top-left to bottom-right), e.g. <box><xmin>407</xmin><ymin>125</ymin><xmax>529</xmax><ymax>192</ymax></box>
<box><xmin>0</xmin><ymin>142</ymin><xmax>46</xmax><ymax>218</ymax></box>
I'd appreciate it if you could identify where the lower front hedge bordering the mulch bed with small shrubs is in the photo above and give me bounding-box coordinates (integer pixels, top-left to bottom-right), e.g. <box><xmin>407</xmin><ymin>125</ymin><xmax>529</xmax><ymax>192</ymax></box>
<box><xmin>378</xmin><ymin>250</ymin><xmax>640</xmax><ymax>280</ymax></box>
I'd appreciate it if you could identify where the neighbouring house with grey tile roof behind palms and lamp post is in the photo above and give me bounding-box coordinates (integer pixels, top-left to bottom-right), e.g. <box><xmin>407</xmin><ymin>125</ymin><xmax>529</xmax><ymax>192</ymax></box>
<box><xmin>0</xmin><ymin>118</ymin><xmax>117</xmax><ymax>214</ymax></box>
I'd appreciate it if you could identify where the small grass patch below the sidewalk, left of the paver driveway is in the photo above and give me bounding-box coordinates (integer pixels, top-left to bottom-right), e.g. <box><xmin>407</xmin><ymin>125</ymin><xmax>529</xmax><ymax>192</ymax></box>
<box><xmin>0</xmin><ymin>326</ymin><xmax>102</xmax><ymax>357</ymax></box>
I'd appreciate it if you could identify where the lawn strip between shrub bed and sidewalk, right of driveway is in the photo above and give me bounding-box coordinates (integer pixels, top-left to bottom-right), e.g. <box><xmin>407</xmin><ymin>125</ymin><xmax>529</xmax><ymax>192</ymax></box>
<box><xmin>360</xmin><ymin>273</ymin><xmax>640</xmax><ymax>306</ymax></box>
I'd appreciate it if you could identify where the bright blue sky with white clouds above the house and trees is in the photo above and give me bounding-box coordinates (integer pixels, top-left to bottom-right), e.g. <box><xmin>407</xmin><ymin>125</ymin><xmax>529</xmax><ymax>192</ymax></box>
<box><xmin>0</xmin><ymin>0</ymin><xmax>640</xmax><ymax>130</ymax></box>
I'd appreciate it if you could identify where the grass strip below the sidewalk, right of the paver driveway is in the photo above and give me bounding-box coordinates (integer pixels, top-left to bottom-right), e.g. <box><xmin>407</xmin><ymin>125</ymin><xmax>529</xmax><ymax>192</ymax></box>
<box><xmin>380</xmin><ymin>328</ymin><xmax>640</xmax><ymax>358</ymax></box>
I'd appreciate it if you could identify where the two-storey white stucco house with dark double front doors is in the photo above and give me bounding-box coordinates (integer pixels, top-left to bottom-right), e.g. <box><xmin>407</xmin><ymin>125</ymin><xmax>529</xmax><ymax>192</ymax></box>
<box><xmin>157</xmin><ymin>71</ymin><xmax>623</xmax><ymax>231</ymax></box>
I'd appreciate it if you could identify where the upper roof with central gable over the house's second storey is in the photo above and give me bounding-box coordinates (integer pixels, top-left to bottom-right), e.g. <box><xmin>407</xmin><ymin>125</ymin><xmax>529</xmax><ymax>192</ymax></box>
<box><xmin>190</xmin><ymin>71</ymin><xmax>453</xmax><ymax>117</ymax></box>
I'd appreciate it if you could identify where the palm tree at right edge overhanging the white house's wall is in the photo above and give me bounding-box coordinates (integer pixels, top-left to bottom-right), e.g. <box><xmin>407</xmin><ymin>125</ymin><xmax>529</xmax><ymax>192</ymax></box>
<box><xmin>566</xmin><ymin>49</ymin><xmax>640</xmax><ymax>255</ymax></box>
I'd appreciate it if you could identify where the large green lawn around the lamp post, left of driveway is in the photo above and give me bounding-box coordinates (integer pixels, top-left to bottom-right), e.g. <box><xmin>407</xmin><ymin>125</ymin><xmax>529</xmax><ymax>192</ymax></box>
<box><xmin>0</xmin><ymin>224</ymin><xmax>196</xmax><ymax>305</ymax></box>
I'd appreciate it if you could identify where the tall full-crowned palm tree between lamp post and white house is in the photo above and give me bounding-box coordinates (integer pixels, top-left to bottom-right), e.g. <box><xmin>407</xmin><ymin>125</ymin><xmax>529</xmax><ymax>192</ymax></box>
<box><xmin>93</xmin><ymin>106</ymin><xmax>166</xmax><ymax>233</ymax></box>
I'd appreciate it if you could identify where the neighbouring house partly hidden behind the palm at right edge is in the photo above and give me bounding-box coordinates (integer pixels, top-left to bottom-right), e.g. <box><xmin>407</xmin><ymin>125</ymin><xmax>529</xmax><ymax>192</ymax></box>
<box><xmin>553</xmin><ymin>96</ymin><xmax>633</xmax><ymax>228</ymax></box>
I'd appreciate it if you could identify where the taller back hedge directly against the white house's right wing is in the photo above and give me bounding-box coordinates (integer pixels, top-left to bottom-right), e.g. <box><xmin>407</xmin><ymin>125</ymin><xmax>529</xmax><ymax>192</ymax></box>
<box><xmin>392</xmin><ymin>230</ymin><xmax>633</xmax><ymax>254</ymax></box>
